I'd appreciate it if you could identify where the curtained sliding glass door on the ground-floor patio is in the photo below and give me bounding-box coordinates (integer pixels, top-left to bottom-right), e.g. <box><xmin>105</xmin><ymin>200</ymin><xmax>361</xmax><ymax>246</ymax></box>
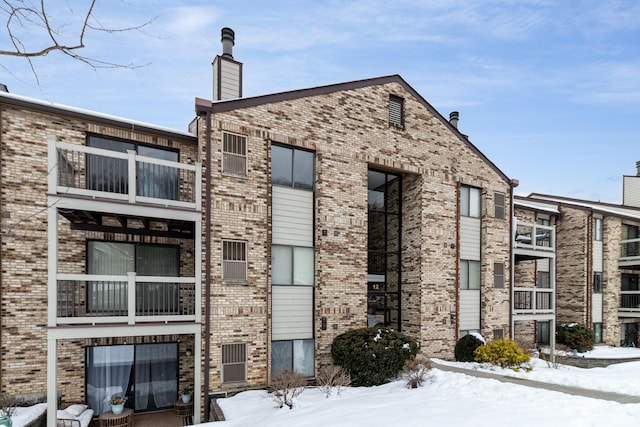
<box><xmin>86</xmin><ymin>343</ymin><xmax>178</xmax><ymax>415</ymax></box>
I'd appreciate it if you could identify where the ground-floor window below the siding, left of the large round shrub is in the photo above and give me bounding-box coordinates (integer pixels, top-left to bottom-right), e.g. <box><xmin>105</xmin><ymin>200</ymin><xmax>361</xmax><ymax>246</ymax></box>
<box><xmin>271</xmin><ymin>339</ymin><xmax>314</xmax><ymax>377</ymax></box>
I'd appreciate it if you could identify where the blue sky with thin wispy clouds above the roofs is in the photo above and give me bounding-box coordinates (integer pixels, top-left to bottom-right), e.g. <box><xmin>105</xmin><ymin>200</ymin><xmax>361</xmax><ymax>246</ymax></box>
<box><xmin>0</xmin><ymin>0</ymin><xmax>640</xmax><ymax>203</ymax></box>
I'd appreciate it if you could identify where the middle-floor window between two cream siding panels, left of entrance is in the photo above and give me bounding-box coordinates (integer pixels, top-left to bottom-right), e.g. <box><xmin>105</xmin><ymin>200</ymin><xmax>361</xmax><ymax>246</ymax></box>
<box><xmin>271</xmin><ymin>245</ymin><xmax>314</xmax><ymax>285</ymax></box>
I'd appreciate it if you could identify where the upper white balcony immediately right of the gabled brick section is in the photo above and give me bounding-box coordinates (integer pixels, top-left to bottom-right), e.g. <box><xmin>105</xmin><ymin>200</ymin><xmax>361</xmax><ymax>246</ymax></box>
<box><xmin>513</xmin><ymin>221</ymin><xmax>556</xmax><ymax>261</ymax></box>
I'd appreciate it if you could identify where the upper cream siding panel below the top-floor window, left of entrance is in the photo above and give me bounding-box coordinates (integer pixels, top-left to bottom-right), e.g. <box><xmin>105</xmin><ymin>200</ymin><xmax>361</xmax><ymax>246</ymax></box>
<box><xmin>272</xmin><ymin>186</ymin><xmax>313</xmax><ymax>247</ymax></box>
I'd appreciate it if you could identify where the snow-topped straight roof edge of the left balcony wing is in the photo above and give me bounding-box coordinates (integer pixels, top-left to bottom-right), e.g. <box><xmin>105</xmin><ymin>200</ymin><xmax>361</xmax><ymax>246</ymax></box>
<box><xmin>0</xmin><ymin>94</ymin><xmax>198</xmax><ymax>142</ymax></box>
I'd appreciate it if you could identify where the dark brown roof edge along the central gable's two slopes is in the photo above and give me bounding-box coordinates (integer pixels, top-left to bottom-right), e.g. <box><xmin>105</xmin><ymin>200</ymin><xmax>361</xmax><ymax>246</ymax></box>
<box><xmin>196</xmin><ymin>74</ymin><xmax>511</xmax><ymax>184</ymax></box>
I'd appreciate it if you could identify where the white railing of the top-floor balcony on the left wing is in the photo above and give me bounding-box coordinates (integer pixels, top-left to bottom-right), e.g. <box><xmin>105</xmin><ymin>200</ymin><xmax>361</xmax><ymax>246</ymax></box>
<box><xmin>49</xmin><ymin>140</ymin><xmax>202</xmax><ymax>210</ymax></box>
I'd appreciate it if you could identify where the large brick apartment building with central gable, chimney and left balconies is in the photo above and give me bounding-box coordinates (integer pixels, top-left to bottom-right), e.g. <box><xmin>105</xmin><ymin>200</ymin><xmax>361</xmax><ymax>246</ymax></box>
<box><xmin>0</xmin><ymin>29</ymin><xmax>560</xmax><ymax>425</ymax></box>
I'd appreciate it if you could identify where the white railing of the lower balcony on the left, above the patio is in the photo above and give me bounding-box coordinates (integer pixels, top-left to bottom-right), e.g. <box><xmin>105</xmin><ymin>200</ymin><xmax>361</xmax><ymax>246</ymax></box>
<box><xmin>56</xmin><ymin>273</ymin><xmax>196</xmax><ymax>325</ymax></box>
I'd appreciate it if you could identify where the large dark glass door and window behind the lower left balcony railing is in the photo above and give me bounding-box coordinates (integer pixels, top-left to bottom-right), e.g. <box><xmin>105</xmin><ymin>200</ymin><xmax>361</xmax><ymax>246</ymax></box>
<box><xmin>87</xmin><ymin>244</ymin><xmax>180</xmax><ymax>315</ymax></box>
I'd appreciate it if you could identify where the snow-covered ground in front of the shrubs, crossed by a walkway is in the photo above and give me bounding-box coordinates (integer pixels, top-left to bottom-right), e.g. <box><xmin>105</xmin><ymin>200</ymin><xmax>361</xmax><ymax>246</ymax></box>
<box><xmin>202</xmin><ymin>347</ymin><xmax>640</xmax><ymax>427</ymax></box>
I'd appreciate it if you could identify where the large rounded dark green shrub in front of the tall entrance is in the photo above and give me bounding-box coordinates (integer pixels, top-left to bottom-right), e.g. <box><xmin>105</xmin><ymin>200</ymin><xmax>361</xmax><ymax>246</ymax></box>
<box><xmin>331</xmin><ymin>327</ymin><xmax>418</xmax><ymax>387</ymax></box>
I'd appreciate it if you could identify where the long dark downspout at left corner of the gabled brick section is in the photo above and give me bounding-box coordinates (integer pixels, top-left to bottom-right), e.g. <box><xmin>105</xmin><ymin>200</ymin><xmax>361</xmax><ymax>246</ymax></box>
<box><xmin>204</xmin><ymin>109</ymin><xmax>211</xmax><ymax>421</ymax></box>
